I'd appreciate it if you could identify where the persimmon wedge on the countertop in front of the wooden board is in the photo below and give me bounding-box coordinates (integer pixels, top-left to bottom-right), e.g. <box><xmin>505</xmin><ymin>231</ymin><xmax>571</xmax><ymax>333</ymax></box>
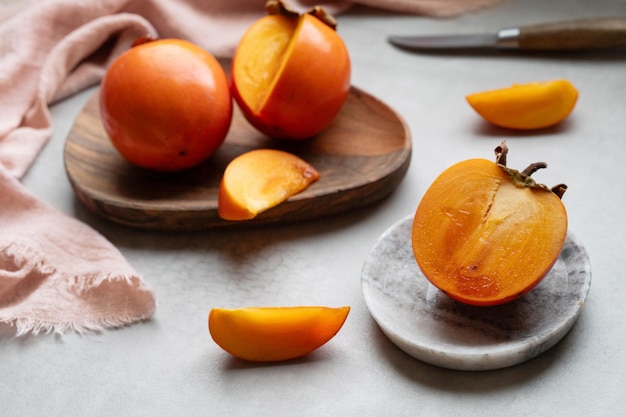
<box><xmin>209</xmin><ymin>306</ymin><xmax>350</xmax><ymax>362</ymax></box>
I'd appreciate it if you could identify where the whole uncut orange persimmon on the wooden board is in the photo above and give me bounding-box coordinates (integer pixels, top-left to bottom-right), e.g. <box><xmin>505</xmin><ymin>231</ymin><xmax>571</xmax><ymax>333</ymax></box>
<box><xmin>100</xmin><ymin>39</ymin><xmax>233</xmax><ymax>171</ymax></box>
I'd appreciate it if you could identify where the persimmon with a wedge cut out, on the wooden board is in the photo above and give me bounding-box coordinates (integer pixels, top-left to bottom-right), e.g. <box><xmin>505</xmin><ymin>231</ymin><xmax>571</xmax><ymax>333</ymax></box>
<box><xmin>231</xmin><ymin>0</ymin><xmax>351</xmax><ymax>139</ymax></box>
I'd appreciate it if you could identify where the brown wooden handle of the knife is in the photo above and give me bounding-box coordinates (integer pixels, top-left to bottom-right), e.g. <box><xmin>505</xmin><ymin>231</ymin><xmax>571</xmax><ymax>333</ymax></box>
<box><xmin>517</xmin><ymin>17</ymin><xmax>626</xmax><ymax>51</ymax></box>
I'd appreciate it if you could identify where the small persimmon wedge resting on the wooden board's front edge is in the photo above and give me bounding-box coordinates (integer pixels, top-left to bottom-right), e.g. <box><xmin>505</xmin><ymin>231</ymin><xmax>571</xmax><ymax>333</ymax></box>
<box><xmin>218</xmin><ymin>149</ymin><xmax>320</xmax><ymax>220</ymax></box>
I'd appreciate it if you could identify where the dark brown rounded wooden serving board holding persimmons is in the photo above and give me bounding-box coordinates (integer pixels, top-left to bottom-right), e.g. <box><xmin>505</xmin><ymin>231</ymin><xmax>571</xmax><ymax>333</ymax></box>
<box><xmin>63</xmin><ymin>87</ymin><xmax>411</xmax><ymax>230</ymax></box>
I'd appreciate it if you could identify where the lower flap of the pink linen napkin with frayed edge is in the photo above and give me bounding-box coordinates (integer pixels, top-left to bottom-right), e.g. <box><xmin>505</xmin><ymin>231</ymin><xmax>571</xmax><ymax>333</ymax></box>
<box><xmin>0</xmin><ymin>168</ymin><xmax>155</xmax><ymax>335</ymax></box>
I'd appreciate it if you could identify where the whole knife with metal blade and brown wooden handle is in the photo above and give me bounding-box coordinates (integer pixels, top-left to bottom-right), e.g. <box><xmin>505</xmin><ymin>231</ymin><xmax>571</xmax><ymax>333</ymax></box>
<box><xmin>388</xmin><ymin>17</ymin><xmax>626</xmax><ymax>51</ymax></box>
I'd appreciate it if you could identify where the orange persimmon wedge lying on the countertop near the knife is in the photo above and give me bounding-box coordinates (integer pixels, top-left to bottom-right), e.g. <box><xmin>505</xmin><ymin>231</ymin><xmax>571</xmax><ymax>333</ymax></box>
<box><xmin>466</xmin><ymin>80</ymin><xmax>578</xmax><ymax>130</ymax></box>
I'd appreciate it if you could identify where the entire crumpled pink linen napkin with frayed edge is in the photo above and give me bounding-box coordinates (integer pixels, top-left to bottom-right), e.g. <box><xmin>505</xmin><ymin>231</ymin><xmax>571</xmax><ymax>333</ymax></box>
<box><xmin>0</xmin><ymin>0</ymin><xmax>500</xmax><ymax>335</ymax></box>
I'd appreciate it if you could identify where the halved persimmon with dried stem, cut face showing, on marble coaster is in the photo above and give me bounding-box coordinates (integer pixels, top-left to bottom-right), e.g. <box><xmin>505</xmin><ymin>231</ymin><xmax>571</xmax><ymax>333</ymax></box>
<box><xmin>412</xmin><ymin>142</ymin><xmax>567</xmax><ymax>306</ymax></box>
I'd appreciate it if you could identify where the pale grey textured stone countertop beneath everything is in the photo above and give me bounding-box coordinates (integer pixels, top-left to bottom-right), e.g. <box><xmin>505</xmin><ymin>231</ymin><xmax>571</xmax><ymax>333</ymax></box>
<box><xmin>0</xmin><ymin>0</ymin><xmax>626</xmax><ymax>417</ymax></box>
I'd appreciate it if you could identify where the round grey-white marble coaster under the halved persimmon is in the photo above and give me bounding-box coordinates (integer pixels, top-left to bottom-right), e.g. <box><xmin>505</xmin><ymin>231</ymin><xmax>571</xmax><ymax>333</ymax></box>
<box><xmin>362</xmin><ymin>216</ymin><xmax>591</xmax><ymax>371</ymax></box>
